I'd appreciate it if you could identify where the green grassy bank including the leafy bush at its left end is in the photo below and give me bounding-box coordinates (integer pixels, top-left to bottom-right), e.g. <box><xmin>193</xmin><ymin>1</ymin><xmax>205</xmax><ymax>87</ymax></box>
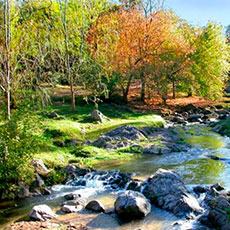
<box><xmin>0</xmin><ymin>102</ymin><xmax>164</xmax><ymax>199</ymax></box>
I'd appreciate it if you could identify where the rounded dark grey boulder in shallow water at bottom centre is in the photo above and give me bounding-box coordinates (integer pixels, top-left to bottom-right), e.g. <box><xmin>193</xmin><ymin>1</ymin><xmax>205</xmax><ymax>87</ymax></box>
<box><xmin>114</xmin><ymin>191</ymin><xmax>151</xmax><ymax>221</ymax></box>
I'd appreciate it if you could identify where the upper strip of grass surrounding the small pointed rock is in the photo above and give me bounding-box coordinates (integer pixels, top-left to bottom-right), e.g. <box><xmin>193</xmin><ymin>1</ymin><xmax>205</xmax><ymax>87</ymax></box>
<box><xmin>44</xmin><ymin>105</ymin><xmax>164</xmax><ymax>140</ymax></box>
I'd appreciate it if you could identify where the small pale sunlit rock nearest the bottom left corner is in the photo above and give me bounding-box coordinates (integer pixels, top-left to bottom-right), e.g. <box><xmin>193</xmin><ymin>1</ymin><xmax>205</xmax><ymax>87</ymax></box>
<box><xmin>30</xmin><ymin>204</ymin><xmax>56</xmax><ymax>221</ymax></box>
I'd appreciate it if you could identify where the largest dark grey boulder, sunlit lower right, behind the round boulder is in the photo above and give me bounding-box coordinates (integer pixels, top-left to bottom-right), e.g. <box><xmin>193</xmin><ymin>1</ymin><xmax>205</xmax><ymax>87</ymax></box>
<box><xmin>143</xmin><ymin>169</ymin><xmax>202</xmax><ymax>216</ymax></box>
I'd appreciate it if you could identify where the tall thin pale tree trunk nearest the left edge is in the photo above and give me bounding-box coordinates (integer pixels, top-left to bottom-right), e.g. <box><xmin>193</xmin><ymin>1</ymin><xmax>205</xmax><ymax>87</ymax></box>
<box><xmin>4</xmin><ymin>0</ymin><xmax>11</xmax><ymax>119</ymax></box>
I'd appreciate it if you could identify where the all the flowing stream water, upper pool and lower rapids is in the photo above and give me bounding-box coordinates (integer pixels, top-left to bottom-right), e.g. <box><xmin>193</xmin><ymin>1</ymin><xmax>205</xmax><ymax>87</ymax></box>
<box><xmin>0</xmin><ymin>125</ymin><xmax>230</xmax><ymax>230</ymax></box>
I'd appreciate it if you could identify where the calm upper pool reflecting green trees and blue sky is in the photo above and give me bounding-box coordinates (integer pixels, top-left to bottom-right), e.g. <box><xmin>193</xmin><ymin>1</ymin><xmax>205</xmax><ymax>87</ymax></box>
<box><xmin>97</xmin><ymin>125</ymin><xmax>230</xmax><ymax>189</ymax></box>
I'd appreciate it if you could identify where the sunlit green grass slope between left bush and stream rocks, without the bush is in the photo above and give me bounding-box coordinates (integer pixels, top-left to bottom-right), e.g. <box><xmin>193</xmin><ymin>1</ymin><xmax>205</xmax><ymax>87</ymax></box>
<box><xmin>35</xmin><ymin>105</ymin><xmax>164</xmax><ymax>167</ymax></box>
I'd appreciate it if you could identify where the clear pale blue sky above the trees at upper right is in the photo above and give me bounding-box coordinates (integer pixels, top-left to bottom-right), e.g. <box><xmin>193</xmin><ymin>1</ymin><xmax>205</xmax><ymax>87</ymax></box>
<box><xmin>165</xmin><ymin>0</ymin><xmax>230</xmax><ymax>26</ymax></box>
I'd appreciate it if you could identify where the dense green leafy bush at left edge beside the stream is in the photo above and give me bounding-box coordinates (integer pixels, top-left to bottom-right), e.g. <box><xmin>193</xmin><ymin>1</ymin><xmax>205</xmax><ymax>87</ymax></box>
<box><xmin>0</xmin><ymin>112</ymin><xmax>42</xmax><ymax>199</ymax></box>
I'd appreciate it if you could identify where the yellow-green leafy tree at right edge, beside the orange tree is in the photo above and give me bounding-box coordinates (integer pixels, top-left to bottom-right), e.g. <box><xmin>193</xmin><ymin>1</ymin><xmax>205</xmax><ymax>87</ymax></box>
<box><xmin>191</xmin><ymin>23</ymin><xmax>229</xmax><ymax>100</ymax></box>
